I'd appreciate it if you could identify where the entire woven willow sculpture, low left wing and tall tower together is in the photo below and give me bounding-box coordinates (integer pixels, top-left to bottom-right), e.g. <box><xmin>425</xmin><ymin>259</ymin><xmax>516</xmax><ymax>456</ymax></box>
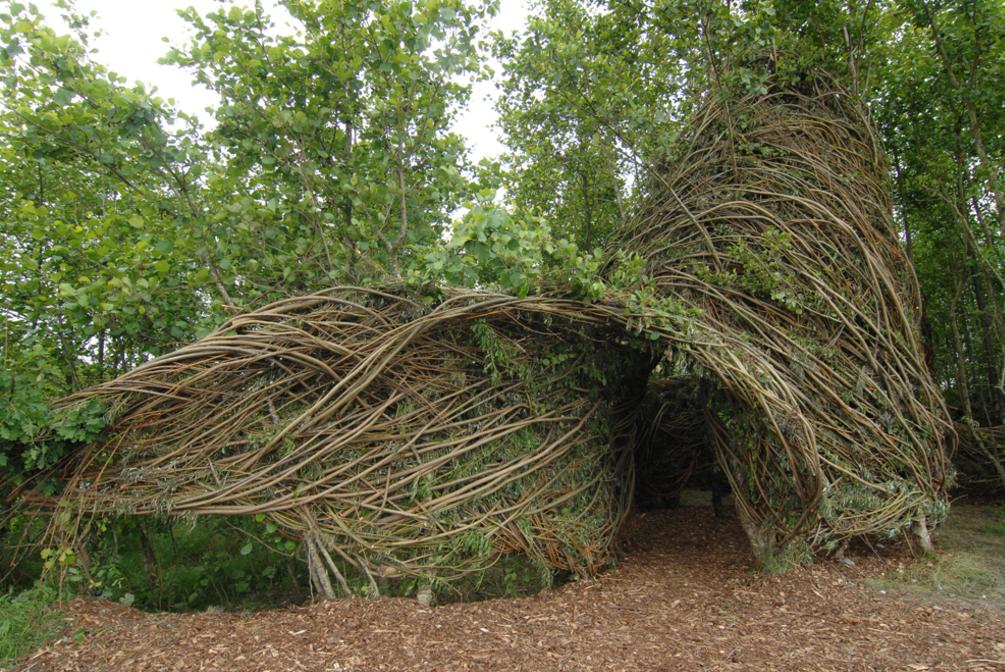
<box><xmin>27</xmin><ymin>74</ymin><xmax>953</xmax><ymax>595</ymax></box>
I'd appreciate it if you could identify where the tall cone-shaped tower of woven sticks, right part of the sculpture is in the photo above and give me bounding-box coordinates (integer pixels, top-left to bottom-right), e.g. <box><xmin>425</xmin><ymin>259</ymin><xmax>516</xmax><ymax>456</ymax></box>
<box><xmin>609</xmin><ymin>81</ymin><xmax>955</xmax><ymax>557</ymax></box>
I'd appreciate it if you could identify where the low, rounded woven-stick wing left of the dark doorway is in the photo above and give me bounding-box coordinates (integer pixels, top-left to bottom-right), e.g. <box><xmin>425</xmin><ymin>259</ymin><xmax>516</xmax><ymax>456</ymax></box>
<box><xmin>39</xmin><ymin>288</ymin><xmax>648</xmax><ymax>596</ymax></box>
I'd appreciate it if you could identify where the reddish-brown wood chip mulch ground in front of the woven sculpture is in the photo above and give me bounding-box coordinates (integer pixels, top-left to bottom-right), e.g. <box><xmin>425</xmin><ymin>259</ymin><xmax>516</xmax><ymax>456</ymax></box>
<box><xmin>9</xmin><ymin>508</ymin><xmax>1005</xmax><ymax>672</ymax></box>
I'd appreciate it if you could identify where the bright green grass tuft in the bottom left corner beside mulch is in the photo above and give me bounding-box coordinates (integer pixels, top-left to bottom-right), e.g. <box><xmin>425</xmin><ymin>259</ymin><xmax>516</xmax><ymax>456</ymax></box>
<box><xmin>0</xmin><ymin>587</ymin><xmax>63</xmax><ymax>668</ymax></box>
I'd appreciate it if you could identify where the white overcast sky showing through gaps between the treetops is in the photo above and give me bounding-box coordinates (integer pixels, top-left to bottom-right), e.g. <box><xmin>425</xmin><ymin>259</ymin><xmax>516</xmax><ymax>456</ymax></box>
<box><xmin>36</xmin><ymin>0</ymin><xmax>527</xmax><ymax>161</ymax></box>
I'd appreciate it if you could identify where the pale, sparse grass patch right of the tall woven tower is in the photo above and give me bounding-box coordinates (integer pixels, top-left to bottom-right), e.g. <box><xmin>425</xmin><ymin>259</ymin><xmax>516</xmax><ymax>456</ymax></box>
<box><xmin>868</xmin><ymin>503</ymin><xmax>1005</xmax><ymax>612</ymax></box>
